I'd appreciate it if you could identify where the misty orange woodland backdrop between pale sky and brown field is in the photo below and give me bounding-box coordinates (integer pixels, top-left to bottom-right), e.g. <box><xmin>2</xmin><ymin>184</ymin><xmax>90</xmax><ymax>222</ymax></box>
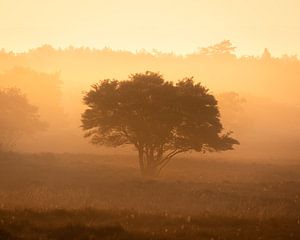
<box><xmin>0</xmin><ymin>41</ymin><xmax>300</xmax><ymax>161</ymax></box>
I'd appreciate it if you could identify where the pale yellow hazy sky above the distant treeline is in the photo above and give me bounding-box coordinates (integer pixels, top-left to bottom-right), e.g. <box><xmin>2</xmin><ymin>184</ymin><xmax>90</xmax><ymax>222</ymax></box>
<box><xmin>0</xmin><ymin>0</ymin><xmax>300</xmax><ymax>56</ymax></box>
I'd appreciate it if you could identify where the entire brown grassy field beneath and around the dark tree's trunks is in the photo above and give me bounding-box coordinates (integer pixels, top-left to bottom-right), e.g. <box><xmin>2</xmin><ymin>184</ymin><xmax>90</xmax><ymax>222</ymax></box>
<box><xmin>0</xmin><ymin>154</ymin><xmax>300</xmax><ymax>240</ymax></box>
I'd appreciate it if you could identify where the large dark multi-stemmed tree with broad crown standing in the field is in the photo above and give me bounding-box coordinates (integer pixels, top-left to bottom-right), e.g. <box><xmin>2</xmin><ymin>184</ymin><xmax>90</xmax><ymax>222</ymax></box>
<box><xmin>82</xmin><ymin>71</ymin><xmax>238</xmax><ymax>176</ymax></box>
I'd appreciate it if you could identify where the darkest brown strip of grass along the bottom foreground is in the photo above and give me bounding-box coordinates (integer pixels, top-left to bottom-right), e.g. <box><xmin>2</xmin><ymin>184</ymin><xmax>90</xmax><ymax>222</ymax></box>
<box><xmin>0</xmin><ymin>209</ymin><xmax>300</xmax><ymax>240</ymax></box>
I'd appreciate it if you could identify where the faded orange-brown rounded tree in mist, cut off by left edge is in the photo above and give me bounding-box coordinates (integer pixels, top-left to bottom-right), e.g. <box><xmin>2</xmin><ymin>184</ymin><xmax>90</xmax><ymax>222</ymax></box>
<box><xmin>0</xmin><ymin>88</ymin><xmax>46</xmax><ymax>152</ymax></box>
